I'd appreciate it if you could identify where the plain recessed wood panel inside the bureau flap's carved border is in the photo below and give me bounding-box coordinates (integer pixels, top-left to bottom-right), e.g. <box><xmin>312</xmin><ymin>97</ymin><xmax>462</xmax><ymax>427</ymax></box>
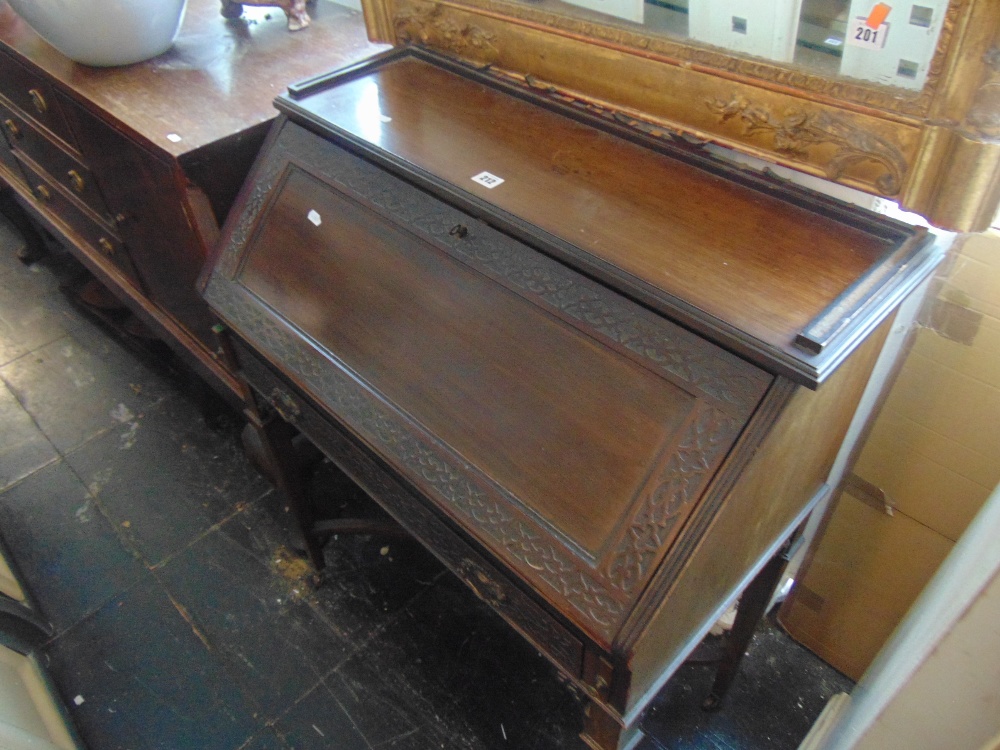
<box><xmin>240</xmin><ymin>172</ymin><xmax>697</xmax><ymax>554</ymax></box>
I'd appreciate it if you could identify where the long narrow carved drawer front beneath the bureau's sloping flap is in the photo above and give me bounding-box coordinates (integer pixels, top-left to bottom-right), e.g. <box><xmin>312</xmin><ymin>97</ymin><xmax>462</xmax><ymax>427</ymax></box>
<box><xmin>236</xmin><ymin>341</ymin><xmax>583</xmax><ymax>678</ymax></box>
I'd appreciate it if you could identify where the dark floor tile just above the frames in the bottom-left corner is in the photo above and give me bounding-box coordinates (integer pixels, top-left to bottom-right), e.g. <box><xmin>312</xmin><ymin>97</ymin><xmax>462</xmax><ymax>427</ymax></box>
<box><xmin>0</xmin><ymin>461</ymin><xmax>143</xmax><ymax>630</ymax></box>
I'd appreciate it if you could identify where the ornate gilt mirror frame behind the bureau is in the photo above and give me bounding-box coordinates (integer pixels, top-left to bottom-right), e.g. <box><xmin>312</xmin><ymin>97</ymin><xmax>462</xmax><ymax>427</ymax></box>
<box><xmin>362</xmin><ymin>0</ymin><xmax>1000</xmax><ymax>231</ymax></box>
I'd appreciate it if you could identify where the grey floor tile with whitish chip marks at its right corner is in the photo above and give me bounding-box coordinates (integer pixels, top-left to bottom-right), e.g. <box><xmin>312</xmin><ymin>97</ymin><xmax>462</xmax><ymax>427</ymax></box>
<box><xmin>0</xmin><ymin>324</ymin><xmax>174</xmax><ymax>454</ymax></box>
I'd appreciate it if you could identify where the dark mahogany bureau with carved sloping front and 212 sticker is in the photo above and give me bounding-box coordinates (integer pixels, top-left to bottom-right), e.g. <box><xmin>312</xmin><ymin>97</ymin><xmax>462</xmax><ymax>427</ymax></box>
<box><xmin>204</xmin><ymin>48</ymin><xmax>938</xmax><ymax>750</ymax></box>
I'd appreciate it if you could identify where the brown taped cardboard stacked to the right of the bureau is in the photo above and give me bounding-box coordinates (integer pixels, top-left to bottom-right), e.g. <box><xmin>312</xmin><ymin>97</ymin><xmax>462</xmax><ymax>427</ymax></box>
<box><xmin>779</xmin><ymin>232</ymin><xmax>1000</xmax><ymax>679</ymax></box>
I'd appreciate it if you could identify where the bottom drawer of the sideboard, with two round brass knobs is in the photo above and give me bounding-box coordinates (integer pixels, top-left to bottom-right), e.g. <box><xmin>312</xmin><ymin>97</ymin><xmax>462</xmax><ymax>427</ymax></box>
<box><xmin>16</xmin><ymin>154</ymin><xmax>142</xmax><ymax>289</ymax></box>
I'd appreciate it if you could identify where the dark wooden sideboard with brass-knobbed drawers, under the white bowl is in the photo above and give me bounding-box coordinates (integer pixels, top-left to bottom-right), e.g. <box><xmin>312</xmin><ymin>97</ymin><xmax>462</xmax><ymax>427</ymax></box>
<box><xmin>0</xmin><ymin>0</ymin><xmax>382</xmax><ymax>407</ymax></box>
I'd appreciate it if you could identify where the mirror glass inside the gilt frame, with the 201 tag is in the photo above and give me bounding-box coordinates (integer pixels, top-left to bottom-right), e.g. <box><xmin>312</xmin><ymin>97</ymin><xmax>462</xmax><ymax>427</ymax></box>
<box><xmin>526</xmin><ymin>0</ymin><xmax>948</xmax><ymax>90</ymax></box>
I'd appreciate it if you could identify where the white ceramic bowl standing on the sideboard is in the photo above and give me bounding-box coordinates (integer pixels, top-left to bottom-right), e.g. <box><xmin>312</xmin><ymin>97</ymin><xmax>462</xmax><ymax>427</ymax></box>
<box><xmin>7</xmin><ymin>0</ymin><xmax>187</xmax><ymax>66</ymax></box>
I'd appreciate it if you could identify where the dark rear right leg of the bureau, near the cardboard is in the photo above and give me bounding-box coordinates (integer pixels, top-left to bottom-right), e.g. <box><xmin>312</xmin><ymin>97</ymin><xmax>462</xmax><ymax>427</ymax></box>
<box><xmin>701</xmin><ymin>525</ymin><xmax>804</xmax><ymax>711</ymax></box>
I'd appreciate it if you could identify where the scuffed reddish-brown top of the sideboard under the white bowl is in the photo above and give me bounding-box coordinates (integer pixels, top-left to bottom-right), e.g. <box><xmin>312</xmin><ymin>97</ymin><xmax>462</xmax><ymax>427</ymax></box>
<box><xmin>0</xmin><ymin>0</ymin><xmax>386</xmax><ymax>157</ymax></box>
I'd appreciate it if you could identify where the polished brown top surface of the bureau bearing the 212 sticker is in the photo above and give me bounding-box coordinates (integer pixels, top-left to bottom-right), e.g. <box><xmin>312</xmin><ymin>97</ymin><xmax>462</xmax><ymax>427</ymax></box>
<box><xmin>294</xmin><ymin>58</ymin><xmax>890</xmax><ymax>364</ymax></box>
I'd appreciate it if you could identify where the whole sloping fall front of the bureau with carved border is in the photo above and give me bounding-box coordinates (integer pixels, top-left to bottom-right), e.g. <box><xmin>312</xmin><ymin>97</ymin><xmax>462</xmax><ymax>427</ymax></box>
<box><xmin>206</xmin><ymin>125</ymin><xmax>770</xmax><ymax>649</ymax></box>
